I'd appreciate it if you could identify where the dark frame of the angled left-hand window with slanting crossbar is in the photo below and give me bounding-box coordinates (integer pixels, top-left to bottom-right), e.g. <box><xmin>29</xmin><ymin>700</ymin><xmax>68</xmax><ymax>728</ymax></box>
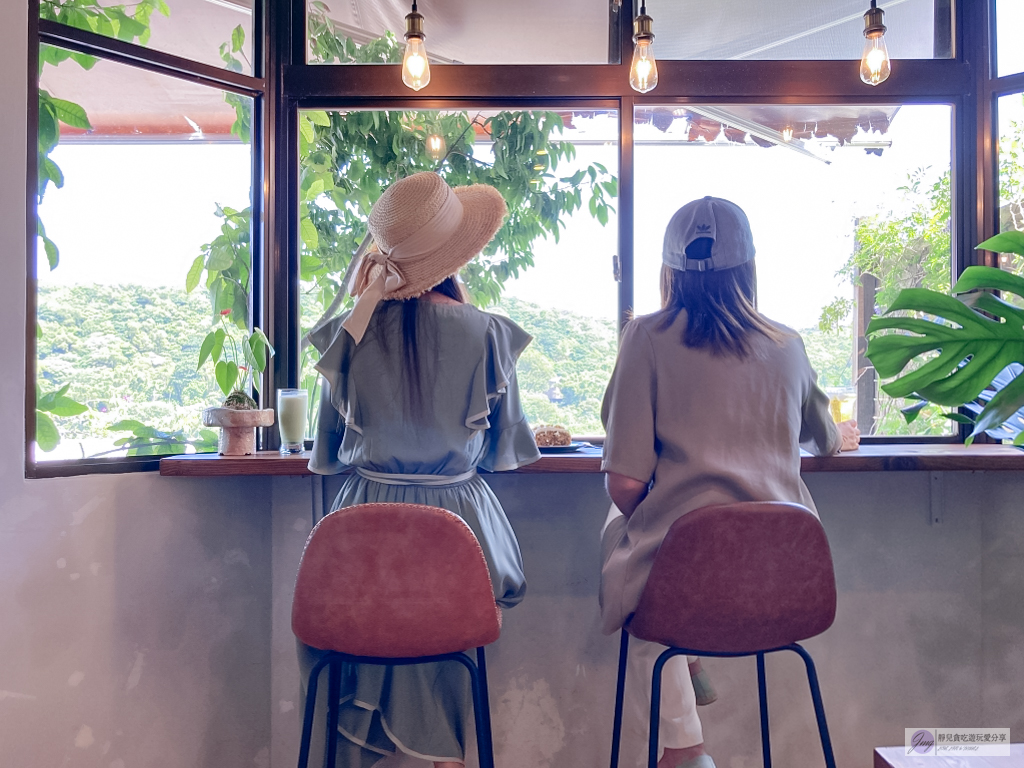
<box><xmin>25</xmin><ymin>0</ymin><xmax>275</xmax><ymax>478</ymax></box>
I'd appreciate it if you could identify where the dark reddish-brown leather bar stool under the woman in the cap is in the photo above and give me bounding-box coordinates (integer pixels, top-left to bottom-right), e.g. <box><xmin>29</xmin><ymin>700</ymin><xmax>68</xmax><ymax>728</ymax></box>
<box><xmin>611</xmin><ymin>502</ymin><xmax>836</xmax><ymax>768</ymax></box>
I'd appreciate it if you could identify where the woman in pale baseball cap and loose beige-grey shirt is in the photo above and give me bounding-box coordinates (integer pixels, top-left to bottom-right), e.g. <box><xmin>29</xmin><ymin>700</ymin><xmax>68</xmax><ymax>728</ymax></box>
<box><xmin>601</xmin><ymin>198</ymin><xmax>860</xmax><ymax>768</ymax></box>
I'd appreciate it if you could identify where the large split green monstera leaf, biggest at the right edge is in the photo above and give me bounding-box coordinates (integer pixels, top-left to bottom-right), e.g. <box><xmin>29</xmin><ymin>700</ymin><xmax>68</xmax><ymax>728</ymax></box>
<box><xmin>866</xmin><ymin>268</ymin><xmax>1024</xmax><ymax>442</ymax></box>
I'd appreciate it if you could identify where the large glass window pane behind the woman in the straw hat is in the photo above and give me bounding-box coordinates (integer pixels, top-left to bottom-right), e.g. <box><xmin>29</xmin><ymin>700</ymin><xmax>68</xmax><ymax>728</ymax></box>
<box><xmin>300</xmin><ymin>110</ymin><xmax>618</xmax><ymax>435</ymax></box>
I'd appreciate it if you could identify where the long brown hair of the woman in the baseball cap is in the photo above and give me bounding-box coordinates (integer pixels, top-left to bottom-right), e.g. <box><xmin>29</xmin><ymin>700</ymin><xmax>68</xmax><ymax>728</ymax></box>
<box><xmin>662</xmin><ymin>238</ymin><xmax>784</xmax><ymax>357</ymax></box>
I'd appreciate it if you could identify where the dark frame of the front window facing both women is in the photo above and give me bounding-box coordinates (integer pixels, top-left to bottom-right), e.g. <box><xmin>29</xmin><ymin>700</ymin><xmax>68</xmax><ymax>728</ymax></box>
<box><xmin>272</xmin><ymin>0</ymin><xmax>994</xmax><ymax>443</ymax></box>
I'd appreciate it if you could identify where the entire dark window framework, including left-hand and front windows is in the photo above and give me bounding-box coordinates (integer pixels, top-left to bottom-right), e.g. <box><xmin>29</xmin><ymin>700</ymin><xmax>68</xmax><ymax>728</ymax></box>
<box><xmin>26</xmin><ymin>0</ymin><xmax>1024</xmax><ymax>476</ymax></box>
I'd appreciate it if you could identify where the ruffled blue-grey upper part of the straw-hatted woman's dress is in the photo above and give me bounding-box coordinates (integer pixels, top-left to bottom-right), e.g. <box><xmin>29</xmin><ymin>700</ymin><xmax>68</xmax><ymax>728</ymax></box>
<box><xmin>309</xmin><ymin>301</ymin><xmax>540</xmax><ymax>475</ymax></box>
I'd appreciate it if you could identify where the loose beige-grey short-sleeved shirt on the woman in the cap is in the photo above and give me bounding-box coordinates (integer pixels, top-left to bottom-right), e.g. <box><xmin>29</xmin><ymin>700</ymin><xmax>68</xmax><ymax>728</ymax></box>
<box><xmin>601</xmin><ymin>311</ymin><xmax>842</xmax><ymax>633</ymax></box>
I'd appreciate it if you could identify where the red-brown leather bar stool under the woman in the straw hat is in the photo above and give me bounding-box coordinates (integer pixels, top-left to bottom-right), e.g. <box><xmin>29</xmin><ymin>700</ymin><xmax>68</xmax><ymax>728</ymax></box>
<box><xmin>292</xmin><ymin>504</ymin><xmax>502</xmax><ymax>768</ymax></box>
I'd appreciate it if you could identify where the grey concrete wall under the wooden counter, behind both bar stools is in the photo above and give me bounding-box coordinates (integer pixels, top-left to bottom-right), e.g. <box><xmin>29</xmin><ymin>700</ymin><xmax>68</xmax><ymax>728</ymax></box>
<box><xmin>272</xmin><ymin>472</ymin><xmax>1024</xmax><ymax>768</ymax></box>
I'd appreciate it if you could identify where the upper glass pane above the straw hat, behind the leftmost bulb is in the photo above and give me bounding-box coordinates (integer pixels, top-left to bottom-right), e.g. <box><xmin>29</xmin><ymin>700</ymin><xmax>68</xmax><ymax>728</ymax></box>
<box><xmin>306</xmin><ymin>0</ymin><xmax>617</xmax><ymax>65</ymax></box>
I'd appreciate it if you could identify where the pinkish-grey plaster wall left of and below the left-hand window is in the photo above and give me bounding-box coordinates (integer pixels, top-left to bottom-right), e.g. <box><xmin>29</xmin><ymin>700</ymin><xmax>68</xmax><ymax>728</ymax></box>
<box><xmin>0</xmin><ymin>7</ymin><xmax>271</xmax><ymax>768</ymax></box>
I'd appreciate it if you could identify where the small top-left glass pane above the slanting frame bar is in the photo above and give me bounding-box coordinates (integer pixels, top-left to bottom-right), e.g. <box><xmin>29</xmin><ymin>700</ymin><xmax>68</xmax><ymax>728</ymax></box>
<box><xmin>39</xmin><ymin>0</ymin><xmax>255</xmax><ymax>75</ymax></box>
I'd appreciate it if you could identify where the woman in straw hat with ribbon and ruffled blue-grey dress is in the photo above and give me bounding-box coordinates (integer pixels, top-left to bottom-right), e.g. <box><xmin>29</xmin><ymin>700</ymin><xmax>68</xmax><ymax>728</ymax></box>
<box><xmin>300</xmin><ymin>173</ymin><xmax>540</xmax><ymax>768</ymax></box>
